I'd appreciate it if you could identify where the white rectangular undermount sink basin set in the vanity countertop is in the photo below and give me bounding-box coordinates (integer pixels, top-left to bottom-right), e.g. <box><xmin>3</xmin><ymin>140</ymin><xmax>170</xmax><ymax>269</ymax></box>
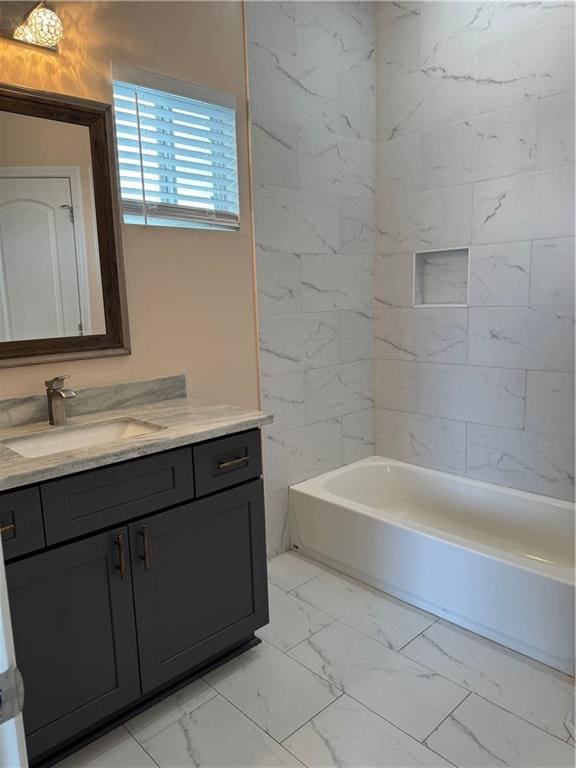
<box><xmin>2</xmin><ymin>418</ymin><xmax>164</xmax><ymax>459</ymax></box>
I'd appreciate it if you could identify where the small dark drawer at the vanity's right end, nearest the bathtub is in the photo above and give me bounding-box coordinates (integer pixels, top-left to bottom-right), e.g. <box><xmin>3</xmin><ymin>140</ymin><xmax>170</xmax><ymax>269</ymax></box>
<box><xmin>193</xmin><ymin>429</ymin><xmax>262</xmax><ymax>496</ymax></box>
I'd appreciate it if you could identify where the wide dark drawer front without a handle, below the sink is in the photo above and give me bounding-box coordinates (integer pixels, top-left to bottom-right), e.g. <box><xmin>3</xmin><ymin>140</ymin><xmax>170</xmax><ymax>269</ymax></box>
<box><xmin>42</xmin><ymin>448</ymin><xmax>194</xmax><ymax>544</ymax></box>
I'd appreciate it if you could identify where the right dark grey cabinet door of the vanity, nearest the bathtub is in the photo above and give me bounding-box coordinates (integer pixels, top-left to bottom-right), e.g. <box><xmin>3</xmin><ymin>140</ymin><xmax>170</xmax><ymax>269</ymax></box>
<box><xmin>130</xmin><ymin>480</ymin><xmax>268</xmax><ymax>692</ymax></box>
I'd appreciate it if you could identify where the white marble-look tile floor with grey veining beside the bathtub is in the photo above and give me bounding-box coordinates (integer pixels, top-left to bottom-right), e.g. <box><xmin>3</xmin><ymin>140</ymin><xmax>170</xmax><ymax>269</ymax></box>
<box><xmin>58</xmin><ymin>552</ymin><xmax>574</xmax><ymax>768</ymax></box>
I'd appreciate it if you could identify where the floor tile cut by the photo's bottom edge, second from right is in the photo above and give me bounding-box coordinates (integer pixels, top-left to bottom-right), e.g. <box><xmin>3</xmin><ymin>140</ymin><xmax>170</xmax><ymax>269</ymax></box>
<box><xmin>284</xmin><ymin>696</ymin><xmax>449</xmax><ymax>768</ymax></box>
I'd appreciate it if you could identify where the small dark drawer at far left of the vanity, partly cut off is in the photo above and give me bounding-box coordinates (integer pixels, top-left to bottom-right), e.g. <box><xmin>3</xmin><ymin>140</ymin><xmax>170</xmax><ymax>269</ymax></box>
<box><xmin>0</xmin><ymin>487</ymin><xmax>45</xmax><ymax>560</ymax></box>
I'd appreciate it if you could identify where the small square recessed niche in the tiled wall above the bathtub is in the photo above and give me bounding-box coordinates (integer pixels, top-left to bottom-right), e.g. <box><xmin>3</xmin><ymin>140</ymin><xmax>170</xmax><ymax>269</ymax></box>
<box><xmin>413</xmin><ymin>248</ymin><xmax>469</xmax><ymax>307</ymax></box>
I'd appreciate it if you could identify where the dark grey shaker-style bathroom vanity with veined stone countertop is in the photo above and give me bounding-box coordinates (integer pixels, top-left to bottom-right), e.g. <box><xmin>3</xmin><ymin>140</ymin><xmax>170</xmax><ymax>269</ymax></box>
<box><xmin>0</xmin><ymin>384</ymin><xmax>268</xmax><ymax>764</ymax></box>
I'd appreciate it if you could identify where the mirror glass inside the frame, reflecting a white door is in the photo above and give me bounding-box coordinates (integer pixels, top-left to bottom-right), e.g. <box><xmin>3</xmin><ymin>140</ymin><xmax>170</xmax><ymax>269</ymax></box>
<box><xmin>0</xmin><ymin>113</ymin><xmax>105</xmax><ymax>342</ymax></box>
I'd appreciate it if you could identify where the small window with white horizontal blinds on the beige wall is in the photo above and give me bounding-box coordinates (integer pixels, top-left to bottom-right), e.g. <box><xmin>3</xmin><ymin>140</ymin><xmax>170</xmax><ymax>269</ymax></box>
<box><xmin>113</xmin><ymin>65</ymin><xmax>240</xmax><ymax>229</ymax></box>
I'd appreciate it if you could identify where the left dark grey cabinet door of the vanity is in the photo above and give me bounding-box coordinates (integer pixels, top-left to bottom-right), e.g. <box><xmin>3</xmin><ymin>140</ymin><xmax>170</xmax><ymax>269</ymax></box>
<box><xmin>6</xmin><ymin>527</ymin><xmax>140</xmax><ymax>758</ymax></box>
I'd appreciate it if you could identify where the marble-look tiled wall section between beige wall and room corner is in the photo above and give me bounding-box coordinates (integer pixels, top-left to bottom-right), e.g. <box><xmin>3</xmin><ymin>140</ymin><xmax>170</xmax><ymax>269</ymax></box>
<box><xmin>246</xmin><ymin>2</ymin><xmax>376</xmax><ymax>556</ymax></box>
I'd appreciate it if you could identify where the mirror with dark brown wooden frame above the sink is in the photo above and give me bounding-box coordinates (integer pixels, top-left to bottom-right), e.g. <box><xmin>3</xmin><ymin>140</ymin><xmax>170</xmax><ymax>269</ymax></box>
<box><xmin>0</xmin><ymin>85</ymin><xmax>130</xmax><ymax>367</ymax></box>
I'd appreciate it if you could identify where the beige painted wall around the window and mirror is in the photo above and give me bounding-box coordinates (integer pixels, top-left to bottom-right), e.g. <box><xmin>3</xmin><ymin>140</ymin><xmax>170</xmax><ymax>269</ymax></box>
<box><xmin>0</xmin><ymin>1</ymin><xmax>259</xmax><ymax>406</ymax></box>
